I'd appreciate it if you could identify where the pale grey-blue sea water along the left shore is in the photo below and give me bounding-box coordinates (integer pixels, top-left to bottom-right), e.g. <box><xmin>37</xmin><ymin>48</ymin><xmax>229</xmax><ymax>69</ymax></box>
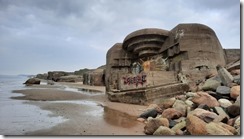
<box><xmin>0</xmin><ymin>75</ymin><xmax>65</xmax><ymax>135</ymax></box>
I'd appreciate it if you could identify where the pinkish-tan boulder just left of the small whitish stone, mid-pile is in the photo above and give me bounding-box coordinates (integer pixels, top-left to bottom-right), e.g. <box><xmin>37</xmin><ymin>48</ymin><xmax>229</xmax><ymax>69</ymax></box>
<box><xmin>192</xmin><ymin>92</ymin><xmax>219</xmax><ymax>107</ymax></box>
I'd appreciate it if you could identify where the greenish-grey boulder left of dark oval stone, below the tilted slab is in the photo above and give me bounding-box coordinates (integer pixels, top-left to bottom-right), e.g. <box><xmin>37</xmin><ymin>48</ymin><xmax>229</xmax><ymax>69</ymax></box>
<box><xmin>201</xmin><ymin>78</ymin><xmax>221</xmax><ymax>91</ymax></box>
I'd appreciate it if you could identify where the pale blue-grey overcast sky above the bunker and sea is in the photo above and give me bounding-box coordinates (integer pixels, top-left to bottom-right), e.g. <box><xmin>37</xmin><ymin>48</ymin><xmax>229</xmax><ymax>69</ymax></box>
<box><xmin>0</xmin><ymin>0</ymin><xmax>240</xmax><ymax>74</ymax></box>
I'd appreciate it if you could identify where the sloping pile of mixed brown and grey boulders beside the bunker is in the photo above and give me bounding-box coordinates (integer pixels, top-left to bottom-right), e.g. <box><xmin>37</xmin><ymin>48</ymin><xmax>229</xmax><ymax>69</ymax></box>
<box><xmin>138</xmin><ymin>66</ymin><xmax>241</xmax><ymax>135</ymax></box>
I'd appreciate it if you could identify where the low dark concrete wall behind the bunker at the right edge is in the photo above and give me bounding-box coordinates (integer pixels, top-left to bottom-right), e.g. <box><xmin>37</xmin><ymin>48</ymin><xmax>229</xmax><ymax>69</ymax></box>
<box><xmin>224</xmin><ymin>49</ymin><xmax>241</xmax><ymax>64</ymax></box>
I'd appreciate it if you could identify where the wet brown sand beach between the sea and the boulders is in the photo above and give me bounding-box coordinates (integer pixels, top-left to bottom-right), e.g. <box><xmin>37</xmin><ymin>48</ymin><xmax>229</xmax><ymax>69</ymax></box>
<box><xmin>12</xmin><ymin>83</ymin><xmax>146</xmax><ymax>135</ymax></box>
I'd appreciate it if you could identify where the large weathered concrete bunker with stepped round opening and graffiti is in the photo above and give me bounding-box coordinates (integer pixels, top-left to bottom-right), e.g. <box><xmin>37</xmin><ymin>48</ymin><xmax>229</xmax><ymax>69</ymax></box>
<box><xmin>105</xmin><ymin>24</ymin><xmax>229</xmax><ymax>104</ymax></box>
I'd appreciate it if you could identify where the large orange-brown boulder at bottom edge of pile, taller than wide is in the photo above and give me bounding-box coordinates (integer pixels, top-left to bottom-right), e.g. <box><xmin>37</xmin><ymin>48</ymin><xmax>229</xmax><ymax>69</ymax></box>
<box><xmin>186</xmin><ymin>115</ymin><xmax>207</xmax><ymax>135</ymax></box>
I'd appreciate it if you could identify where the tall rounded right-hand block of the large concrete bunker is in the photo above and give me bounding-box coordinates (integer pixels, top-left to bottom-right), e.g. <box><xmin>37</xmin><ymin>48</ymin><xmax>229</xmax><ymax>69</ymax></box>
<box><xmin>160</xmin><ymin>24</ymin><xmax>226</xmax><ymax>89</ymax></box>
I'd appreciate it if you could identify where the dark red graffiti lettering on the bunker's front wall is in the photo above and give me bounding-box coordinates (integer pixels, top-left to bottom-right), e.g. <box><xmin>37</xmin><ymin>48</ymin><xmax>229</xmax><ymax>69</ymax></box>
<box><xmin>123</xmin><ymin>75</ymin><xmax>147</xmax><ymax>87</ymax></box>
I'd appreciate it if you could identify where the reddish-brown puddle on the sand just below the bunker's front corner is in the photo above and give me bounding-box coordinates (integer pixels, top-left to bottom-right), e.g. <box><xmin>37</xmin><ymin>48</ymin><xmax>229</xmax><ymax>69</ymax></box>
<box><xmin>103</xmin><ymin>107</ymin><xmax>138</xmax><ymax>128</ymax></box>
